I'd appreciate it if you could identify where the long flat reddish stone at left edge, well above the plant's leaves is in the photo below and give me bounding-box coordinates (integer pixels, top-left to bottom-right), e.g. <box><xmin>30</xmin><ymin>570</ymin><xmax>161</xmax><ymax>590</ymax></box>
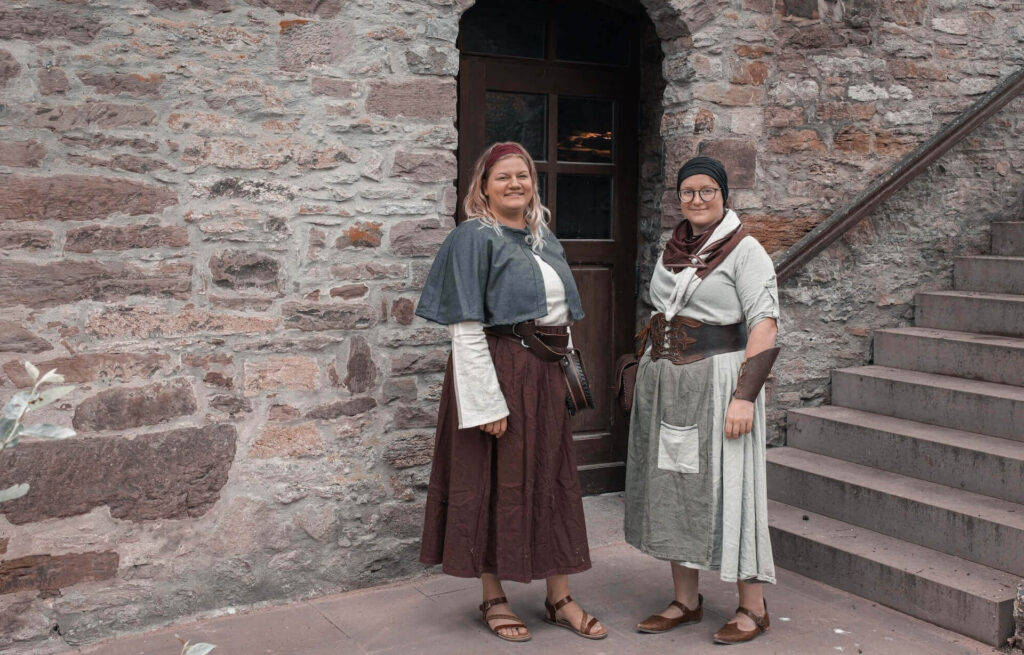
<box><xmin>0</xmin><ymin>261</ymin><xmax>191</xmax><ymax>307</ymax></box>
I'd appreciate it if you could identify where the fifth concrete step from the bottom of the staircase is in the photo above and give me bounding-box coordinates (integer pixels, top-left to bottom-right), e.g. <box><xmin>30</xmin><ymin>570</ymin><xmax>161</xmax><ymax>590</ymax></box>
<box><xmin>874</xmin><ymin>328</ymin><xmax>1024</xmax><ymax>387</ymax></box>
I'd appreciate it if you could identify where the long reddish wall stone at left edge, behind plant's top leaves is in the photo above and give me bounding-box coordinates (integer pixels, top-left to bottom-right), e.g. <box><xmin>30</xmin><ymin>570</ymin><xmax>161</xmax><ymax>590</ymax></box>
<box><xmin>3</xmin><ymin>352</ymin><xmax>170</xmax><ymax>388</ymax></box>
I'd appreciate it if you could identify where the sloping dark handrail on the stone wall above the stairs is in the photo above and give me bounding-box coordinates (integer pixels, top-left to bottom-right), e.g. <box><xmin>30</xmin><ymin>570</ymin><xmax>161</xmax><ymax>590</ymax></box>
<box><xmin>775</xmin><ymin>69</ymin><xmax>1024</xmax><ymax>282</ymax></box>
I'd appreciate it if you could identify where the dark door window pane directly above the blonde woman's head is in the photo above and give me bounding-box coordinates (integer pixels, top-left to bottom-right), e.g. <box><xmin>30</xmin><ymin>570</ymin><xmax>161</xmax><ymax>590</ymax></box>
<box><xmin>484</xmin><ymin>91</ymin><xmax>548</xmax><ymax>161</ymax></box>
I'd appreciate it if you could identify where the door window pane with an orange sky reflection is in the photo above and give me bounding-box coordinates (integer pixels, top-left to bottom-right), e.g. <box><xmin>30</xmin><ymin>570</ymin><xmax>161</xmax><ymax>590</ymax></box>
<box><xmin>558</xmin><ymin>96</ymin><xmax>614</xmax><ymax>163</ymax></box>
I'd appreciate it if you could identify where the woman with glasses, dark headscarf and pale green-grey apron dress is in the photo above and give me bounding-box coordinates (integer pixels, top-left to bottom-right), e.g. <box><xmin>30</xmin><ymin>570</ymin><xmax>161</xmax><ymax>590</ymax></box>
<box><xmin>626</xmin><ymin>157</ymin><xmax>779</xmax><ymax>644</ymax></box>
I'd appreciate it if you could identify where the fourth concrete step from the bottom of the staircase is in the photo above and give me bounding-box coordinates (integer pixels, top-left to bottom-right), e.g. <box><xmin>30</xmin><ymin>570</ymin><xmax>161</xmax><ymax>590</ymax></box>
<box><xmin>831</xmin><ymin>366</ymin><xmax>1024</xmax><ymax>441</ymax></box>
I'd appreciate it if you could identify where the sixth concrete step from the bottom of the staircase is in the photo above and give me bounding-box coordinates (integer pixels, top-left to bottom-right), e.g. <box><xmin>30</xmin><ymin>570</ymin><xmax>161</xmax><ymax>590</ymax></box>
<box><xmin>913</xmin><ymin>291</ymin><xmax>1024</xmax><ymax>337</ymax></box>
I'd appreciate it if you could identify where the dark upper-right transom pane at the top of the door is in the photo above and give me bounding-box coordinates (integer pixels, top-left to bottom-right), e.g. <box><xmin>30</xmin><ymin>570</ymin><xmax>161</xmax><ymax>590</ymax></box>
<box><xmin>555</xmin><ymin>0</ymin><xmax>630</xmax><ymax>66</ymax></box>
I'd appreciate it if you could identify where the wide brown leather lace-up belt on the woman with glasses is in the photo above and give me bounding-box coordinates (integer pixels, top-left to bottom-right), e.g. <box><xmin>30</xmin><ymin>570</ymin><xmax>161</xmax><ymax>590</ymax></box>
<box><xmin>637</xmin><ymin>313</ymin><xmax>746</xmax><ymax>364</ymax></box>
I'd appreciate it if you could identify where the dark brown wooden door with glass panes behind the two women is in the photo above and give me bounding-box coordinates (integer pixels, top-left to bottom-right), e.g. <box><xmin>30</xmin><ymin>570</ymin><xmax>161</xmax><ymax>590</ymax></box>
<box><xmin>459</xmin><ymin>0</ymin><xmax>640</xmax><ymax>493</ymax></box>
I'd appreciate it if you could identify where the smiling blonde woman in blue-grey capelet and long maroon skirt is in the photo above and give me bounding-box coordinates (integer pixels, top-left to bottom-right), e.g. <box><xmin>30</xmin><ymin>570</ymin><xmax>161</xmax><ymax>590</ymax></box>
<box><xmin>416</xmin><ymin>142</ymin><xmax>607</xmax><ymax>642</ymax></box>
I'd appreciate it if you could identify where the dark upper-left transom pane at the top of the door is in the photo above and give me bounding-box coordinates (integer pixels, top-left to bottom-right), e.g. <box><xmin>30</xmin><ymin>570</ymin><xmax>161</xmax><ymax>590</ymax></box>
<box><xmin>461</xmin><ymin>0</ymin><xmax>546</xmax><ymax>59</ymax></box>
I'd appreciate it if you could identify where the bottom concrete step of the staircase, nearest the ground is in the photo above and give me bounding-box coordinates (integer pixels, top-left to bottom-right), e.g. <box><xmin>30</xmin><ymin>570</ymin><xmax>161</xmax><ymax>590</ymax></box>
<box><xmin>768</xmin><ymin>500</ymin><xmax>1017</xmax><ymax>647</ymax></box>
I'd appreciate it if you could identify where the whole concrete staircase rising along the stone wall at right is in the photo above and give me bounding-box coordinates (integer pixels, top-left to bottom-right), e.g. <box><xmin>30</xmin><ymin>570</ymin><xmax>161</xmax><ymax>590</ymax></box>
<box><xmin>768</xmin><ymin>222</ymin><xmax>1024</xmax><ymax>646</ymax></box>
